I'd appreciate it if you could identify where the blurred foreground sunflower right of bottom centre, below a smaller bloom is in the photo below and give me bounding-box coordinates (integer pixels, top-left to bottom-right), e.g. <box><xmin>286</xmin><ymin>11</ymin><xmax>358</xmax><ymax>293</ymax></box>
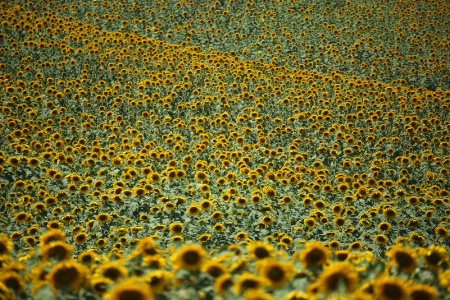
<box><xmin>257</xmin><ymin>259</ymin><xmax>294</xmax><ymax>289</ymax></box>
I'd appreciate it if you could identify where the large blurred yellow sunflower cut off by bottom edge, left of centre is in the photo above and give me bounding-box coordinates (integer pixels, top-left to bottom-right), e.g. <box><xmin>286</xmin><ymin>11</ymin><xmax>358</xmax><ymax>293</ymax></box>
<box><xmin>104</xmin><ymin>277</ymin><xmax>154</xmax><ymax>300</ymax></box>
